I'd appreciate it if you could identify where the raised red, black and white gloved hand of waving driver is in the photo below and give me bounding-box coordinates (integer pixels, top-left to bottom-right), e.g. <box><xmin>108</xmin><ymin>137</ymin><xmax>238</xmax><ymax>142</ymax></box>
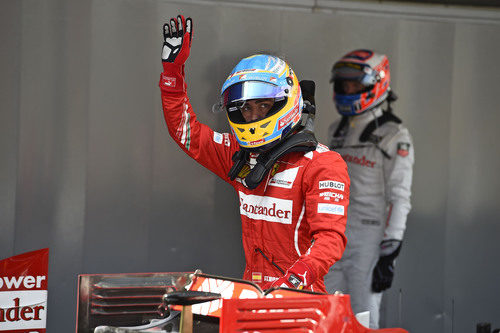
<box><xmin>160</xmin><ymin>15</ymin><xmax>193</xmax><ymax>91</ymax></box>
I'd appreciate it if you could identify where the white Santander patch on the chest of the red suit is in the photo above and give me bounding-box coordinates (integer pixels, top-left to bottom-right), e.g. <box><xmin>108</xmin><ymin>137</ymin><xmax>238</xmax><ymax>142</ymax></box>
<box><xmin>238</xmin><ymin>191</ymin><xmax>293</xmax><ymax>224</ymax></box>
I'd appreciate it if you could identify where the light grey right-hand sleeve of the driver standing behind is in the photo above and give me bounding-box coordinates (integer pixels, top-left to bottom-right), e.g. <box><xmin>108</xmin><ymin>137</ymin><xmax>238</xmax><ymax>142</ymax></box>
<box><xmin>382</xmin><ymin>126</ymin><xmax>415</xmax><ymax>240</ymax></box>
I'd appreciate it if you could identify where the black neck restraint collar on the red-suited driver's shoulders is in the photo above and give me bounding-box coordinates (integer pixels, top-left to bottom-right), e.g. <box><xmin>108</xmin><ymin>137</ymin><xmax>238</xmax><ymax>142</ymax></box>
<box><xmin>228</xmin><ymin>80</ymin><xmax>318</xmax><ymax>190</ymax></box>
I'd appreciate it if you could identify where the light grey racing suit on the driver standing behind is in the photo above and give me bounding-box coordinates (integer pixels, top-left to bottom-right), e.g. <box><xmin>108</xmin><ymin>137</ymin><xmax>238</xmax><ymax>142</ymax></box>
<box><xmin>325</xmin><ymin>107</ymin><xmax>414</xmax><ymax>328</ymax></box>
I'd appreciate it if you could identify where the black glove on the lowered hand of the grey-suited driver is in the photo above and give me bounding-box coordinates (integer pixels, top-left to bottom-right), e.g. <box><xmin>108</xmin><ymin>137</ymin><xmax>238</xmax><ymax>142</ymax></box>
<box><xmin>372</xmin><ymin>239</ymin><xmax>402</xmax><ymax>293</ymax></box>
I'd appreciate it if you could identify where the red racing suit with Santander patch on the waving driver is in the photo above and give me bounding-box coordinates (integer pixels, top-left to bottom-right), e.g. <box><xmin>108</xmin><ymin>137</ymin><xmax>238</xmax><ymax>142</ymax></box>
<box><xmin>160</xmin><ymin>72</ymin><xmax>349</xmax><ymax>292</ymax></box>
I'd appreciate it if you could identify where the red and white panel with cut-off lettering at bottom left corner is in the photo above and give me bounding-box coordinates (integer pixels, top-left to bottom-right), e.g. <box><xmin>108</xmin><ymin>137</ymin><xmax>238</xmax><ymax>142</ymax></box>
<box><xmin>0</xmin><ymin>249</ymin><xmax>49</xmax><ymax>333</ymax></box>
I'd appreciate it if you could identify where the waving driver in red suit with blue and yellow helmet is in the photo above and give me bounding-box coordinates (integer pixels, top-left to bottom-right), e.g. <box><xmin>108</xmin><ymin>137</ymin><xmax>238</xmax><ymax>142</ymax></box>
<box><xmin>160</xmin><ymin>16</ymin><xmax>349</xmax><ymax>292</ymax></box>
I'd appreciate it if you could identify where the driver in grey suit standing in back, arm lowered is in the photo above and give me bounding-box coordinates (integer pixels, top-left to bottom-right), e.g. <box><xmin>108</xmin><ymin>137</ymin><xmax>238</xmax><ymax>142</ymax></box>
<box><xmin>325</xmin><ymin>50</ymin><xmax>414</xmax><ymax>328</ymax></box>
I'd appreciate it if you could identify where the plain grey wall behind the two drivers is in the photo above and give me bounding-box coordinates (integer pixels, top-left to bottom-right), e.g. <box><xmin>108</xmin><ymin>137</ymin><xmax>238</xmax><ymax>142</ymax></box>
<box><xmin>0</xmin><ymin>0</ymin><xmax>500</xmax><ymax>333</ymax></box>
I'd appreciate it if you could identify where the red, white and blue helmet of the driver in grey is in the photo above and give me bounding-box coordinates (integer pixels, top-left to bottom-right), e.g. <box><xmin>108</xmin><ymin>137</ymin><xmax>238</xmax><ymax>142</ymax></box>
<box><xmin>330</xmin><ymin>50</ymin><xmax>391</xmax><ymax>116</ymax></box>
